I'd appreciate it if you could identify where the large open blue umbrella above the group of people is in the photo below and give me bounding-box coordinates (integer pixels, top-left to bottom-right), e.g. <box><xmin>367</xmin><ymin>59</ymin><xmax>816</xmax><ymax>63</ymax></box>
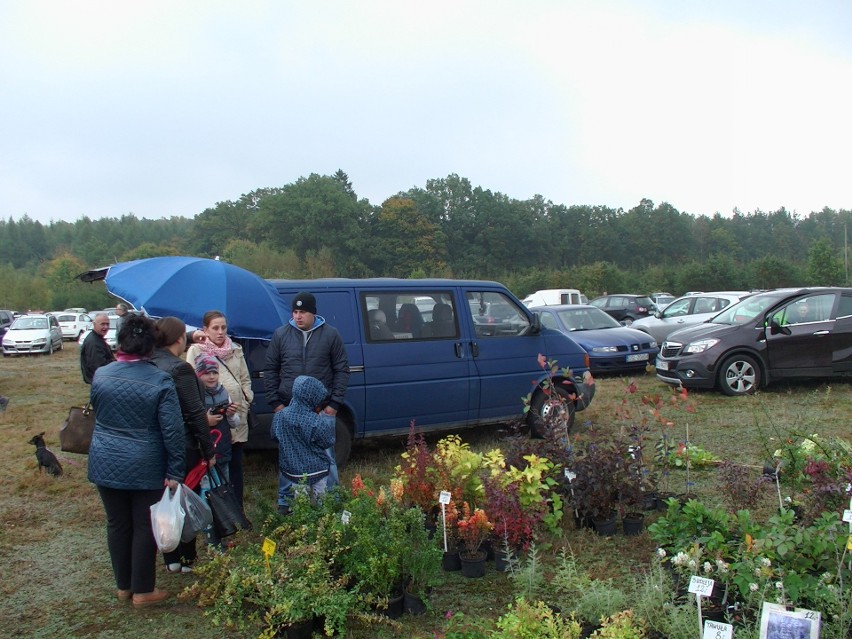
<box><xmin>98</xmin><ymin>257</ymin><xmax>291</xmax><ymax>339</ymax></box>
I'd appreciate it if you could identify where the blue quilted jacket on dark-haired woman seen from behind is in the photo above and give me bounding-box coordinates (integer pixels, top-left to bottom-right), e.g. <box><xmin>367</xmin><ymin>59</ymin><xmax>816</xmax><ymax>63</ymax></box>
<box><xmin>89</xmin><ymin>360</ymin><xmax>186</xmax><ymax>490</ymax></box>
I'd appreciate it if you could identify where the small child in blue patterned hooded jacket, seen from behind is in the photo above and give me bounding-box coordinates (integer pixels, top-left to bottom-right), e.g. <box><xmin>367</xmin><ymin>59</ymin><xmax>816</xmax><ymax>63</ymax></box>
<box><xmin>272</xmin><ymin>375</ymin><xmax>336</xmax><ymax>499</ymax></box>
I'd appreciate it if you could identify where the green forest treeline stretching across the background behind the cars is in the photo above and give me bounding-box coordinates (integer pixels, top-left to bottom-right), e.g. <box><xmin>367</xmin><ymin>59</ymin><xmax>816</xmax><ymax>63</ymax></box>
<box><xmin>0</xmin><ymin>171</ymin><xmax>852</xmax><ymax>311</ymax></box>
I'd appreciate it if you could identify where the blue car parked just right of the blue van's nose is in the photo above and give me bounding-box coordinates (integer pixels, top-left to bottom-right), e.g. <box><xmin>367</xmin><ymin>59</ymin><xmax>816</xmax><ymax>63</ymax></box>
<box><xmin>530</xmin><ymin>304</ymin><xmax>660</xmax><ymax>374</ymax></box>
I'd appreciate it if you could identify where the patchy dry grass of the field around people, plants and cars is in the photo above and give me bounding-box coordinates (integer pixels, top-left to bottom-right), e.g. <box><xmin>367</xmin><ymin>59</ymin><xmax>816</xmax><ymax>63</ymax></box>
<box><xmin>0</xmin><ymin>343</ymin><xmax>852</xmax><ymax>639</ymax></box>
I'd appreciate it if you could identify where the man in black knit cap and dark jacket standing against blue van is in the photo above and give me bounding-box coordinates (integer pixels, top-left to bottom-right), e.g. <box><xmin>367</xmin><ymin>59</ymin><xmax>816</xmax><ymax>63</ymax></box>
<box><xmin>263</xmin><ymin>293</ymin><xmax>349</xmax><ymax>513</ymax></box>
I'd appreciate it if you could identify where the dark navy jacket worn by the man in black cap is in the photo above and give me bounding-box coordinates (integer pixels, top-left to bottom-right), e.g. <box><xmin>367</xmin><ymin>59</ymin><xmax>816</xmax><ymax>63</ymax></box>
<box><xmin>263</xmin><ymin>315</ymin><xmax>349</xmax><ymax>409</ymax></box>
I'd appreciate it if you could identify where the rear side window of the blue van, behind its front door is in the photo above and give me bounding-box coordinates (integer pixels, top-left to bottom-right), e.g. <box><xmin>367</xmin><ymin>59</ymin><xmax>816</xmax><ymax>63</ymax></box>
<box><xmin>360</xmin><ymin>291</ymin><xmax>459</xmax><ymax>342</ymax></box>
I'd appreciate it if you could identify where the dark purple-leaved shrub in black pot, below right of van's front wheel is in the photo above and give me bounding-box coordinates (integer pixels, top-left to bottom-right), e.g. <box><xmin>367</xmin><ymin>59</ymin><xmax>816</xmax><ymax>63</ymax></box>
<box><xmin>569</xmin><ymin>436</ymin><xmax>624</xmax><ymax>535</ymax></box>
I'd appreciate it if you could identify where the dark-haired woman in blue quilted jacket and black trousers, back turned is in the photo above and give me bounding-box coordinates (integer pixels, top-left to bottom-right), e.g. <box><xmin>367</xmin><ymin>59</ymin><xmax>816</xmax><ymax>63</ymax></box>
<box><xmin>89</xmin><ymin>315</ymin><xmax>186</xmax><ymax>608</ymax></box>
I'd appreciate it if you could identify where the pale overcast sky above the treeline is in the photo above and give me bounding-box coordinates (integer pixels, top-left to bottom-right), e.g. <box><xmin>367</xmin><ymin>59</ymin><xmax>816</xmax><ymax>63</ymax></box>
<box><xmin>0</xmin><ymin>0</ymin><xmax>852</xmax><ymax>222</ymax></box>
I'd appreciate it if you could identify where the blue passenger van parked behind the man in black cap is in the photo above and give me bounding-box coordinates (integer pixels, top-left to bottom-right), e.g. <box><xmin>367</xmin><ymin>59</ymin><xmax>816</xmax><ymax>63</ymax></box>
<box><xmin>241</xmin><ymin>278</ymin><xmax>594</xmax><ymax>464</ymax></box>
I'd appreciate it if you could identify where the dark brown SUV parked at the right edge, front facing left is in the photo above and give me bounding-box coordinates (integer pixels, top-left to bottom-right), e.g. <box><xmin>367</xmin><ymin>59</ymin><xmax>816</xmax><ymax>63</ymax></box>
<box><xmin>656</xmin><ymin>288</ymin><xmax>852</xmax><ymax>395</ymax></box>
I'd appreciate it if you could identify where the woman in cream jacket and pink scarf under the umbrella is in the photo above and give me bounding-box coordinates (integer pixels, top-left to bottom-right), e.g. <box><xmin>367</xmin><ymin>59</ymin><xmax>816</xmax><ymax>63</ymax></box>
<box><xmin>186</xmin><ymin>311</ymin><xmax>254</xmax><ymax>506</ymax></box>
